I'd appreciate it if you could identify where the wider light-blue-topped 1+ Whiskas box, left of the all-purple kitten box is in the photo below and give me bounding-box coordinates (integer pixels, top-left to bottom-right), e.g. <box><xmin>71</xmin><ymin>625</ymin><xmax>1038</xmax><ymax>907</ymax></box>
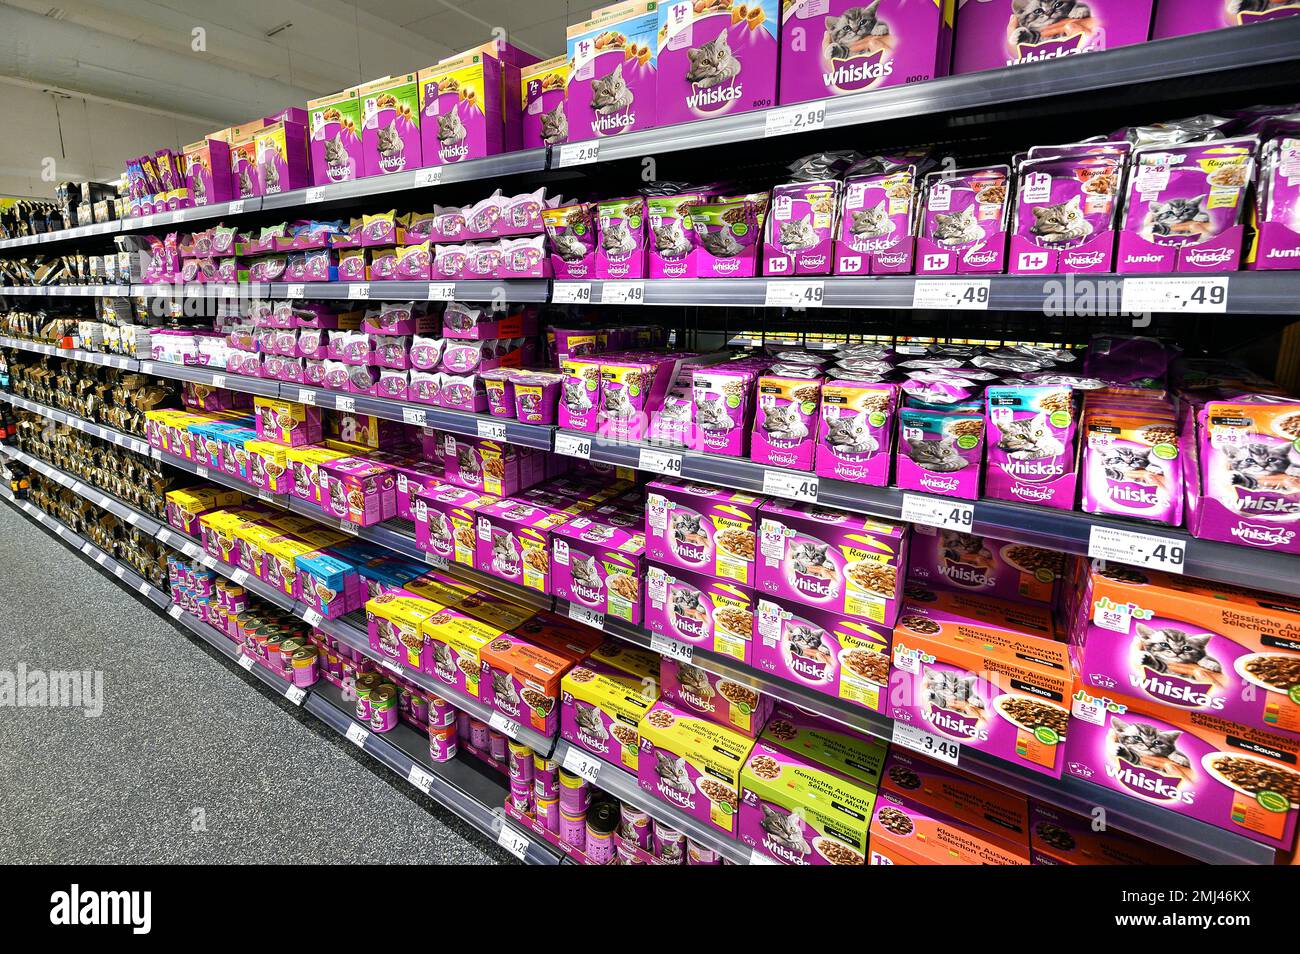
<box><xmin>655</xmin><ymin>0</ymin><xmax>780</xmax><ymax>126</ymax></box>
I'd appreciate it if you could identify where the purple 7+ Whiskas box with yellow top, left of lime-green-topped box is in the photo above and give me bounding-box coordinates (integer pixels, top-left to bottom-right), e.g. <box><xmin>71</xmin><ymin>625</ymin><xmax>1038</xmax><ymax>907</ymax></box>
<box><xmin>637</xmin><ymin>699</ymin><xmax>754</xmax><ymax>837</ymax></box>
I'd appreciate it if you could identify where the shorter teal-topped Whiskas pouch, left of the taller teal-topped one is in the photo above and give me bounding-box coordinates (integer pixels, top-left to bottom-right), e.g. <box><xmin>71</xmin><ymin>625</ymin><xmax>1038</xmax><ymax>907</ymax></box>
<box><xmin>894</xmin><ymin>407</ymin><xmax>984</xmax><ymax>500</ymax></box>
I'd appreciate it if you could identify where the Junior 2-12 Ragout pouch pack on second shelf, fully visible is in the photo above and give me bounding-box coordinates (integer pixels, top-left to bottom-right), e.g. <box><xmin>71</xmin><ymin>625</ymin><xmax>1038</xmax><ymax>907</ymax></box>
<box><xmin>1115</xmin><ymin>136</ymin><xmax>1258</xmax><ymax>272</ymax></box>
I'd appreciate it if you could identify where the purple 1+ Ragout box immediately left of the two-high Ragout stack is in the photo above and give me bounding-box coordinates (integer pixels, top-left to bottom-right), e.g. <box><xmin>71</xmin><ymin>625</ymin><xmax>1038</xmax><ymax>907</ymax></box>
<box><xmin>551</xmin><ymin>517</ymin><xmax>645</xmax><ymax>625</ymax></box>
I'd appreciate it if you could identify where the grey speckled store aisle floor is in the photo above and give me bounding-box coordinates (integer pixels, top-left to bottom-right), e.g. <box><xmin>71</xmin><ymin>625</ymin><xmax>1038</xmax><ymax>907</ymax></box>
<box><xmin>0</xmin><ymin>503</ymin><xmax>507</xmax><ymax>864</ymax></box>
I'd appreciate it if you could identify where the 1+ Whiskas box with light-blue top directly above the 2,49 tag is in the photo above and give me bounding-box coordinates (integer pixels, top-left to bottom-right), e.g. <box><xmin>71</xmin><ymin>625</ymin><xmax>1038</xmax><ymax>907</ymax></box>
<box><xmin>564</xmin><ymin>0</ymin><xmax>659</xmax><ymax>143</ymax></box>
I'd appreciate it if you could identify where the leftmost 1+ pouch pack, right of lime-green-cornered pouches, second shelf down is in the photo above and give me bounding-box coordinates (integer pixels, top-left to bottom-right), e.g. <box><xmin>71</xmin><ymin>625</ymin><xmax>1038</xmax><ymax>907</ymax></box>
<box><xmin>763</xmin><ymin>179</ymin><xmax>840</xmax><ymax>276</ymax></box>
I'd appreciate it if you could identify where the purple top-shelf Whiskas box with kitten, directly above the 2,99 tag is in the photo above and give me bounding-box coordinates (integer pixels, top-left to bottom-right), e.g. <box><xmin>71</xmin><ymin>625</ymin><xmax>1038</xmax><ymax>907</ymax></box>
<box><xmin>780</xmin><ymin>0</ymin><xmax>956</xmax><ymax>104</ymax></box>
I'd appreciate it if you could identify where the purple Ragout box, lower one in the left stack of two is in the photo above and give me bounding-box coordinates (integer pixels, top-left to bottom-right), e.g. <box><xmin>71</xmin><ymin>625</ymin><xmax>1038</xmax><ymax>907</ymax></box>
<box><xmin>645</xmin><ymin>563</ymin><xmax>754</xmax><ymax>663</ymax></box>
